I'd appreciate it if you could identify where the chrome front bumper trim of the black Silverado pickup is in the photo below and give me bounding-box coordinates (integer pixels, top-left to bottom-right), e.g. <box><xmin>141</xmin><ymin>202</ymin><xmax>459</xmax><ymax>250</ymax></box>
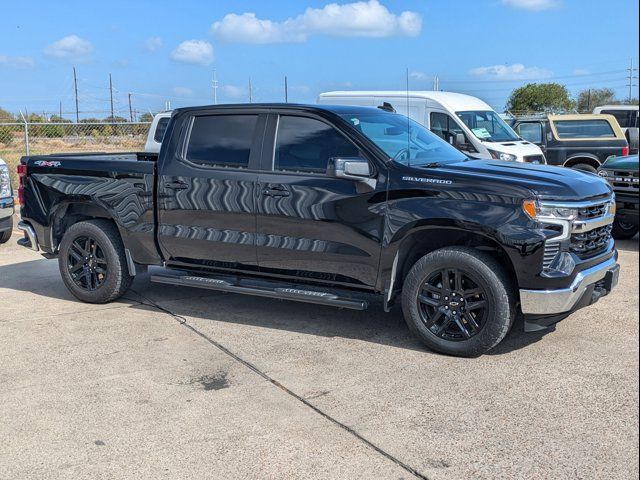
<box><xmin>520</xmin><ymin>257</ymin><xmax>617</xmax><ymax>315</ymax></box>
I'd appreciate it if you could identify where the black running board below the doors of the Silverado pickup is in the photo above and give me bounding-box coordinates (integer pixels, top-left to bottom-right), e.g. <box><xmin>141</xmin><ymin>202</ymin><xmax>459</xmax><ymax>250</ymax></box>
<box><xmin>151</xmin><ymin>274</ymin><xmax>369</xmax><ymax>310</ymax></box>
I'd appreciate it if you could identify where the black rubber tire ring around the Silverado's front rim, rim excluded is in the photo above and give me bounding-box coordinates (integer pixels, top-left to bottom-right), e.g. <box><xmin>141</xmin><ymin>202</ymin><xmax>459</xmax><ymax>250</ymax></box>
<box><xmin>402</xmin><ymin>249</ymin><xmax>513</xmax><ymax>356</ymax></box>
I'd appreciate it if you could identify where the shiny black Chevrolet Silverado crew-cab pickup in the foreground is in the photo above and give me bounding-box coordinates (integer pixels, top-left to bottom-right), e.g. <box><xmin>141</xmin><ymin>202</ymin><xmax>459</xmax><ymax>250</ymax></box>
<box><xmin>18</xmin><ymin>104</ymin><xmax>619</xmax><ymax>356</ymax></box>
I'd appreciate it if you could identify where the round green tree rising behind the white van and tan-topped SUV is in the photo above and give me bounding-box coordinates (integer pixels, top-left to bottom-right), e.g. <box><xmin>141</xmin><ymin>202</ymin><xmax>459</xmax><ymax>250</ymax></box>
<box><xmin>507</xmin><ymin>83</ymin><xmax>575</xmax><ymax>113</ymax></box>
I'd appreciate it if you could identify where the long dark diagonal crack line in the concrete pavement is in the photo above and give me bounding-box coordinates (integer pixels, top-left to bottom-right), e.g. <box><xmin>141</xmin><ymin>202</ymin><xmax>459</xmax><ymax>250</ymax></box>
<box><xmin>131</xmin><ymin>289</ymin><xmax>429</xmax><ymax>480</ymax></box>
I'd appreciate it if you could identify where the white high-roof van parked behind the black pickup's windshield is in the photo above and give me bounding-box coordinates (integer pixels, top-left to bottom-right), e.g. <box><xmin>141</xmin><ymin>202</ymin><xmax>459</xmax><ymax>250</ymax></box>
<box><xmin>318</xmin><ymin>91</ymin><xmax>546</xmax><ymax>163</ymax></box>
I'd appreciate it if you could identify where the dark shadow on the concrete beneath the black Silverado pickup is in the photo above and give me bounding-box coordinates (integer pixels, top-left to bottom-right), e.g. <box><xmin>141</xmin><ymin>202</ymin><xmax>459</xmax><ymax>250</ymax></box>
<box><xmin>0</xmin><ymin>259</ymin><xmax>549</xmax><ymax>355</ymax></box>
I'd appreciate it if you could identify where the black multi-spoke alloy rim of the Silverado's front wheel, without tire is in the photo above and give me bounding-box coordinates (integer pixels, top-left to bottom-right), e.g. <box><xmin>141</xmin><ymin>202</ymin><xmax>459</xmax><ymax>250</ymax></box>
<box><xmin>417</xmin><ymin>268</ymin><xmax>488</xmax><ymax>341</ymax></box>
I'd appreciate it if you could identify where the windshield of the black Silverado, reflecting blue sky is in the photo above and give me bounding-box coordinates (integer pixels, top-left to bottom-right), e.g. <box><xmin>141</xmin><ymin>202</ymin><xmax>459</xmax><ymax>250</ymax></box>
<box><xmin>341</xmin><ymin>111</ymin><xmax>467</xmax><ymax>167</ymax></box>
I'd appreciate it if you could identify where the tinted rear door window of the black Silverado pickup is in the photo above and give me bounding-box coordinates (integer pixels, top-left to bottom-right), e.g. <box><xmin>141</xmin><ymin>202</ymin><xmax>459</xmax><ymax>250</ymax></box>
<box><xmin>187</xmin><ymin>115</ymin><xmax>258</xmax><ymax>168</ymax></box>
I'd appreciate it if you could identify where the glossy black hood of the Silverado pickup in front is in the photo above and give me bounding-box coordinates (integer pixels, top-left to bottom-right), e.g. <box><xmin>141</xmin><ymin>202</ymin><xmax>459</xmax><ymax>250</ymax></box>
<box><xmin>442</xmin><ymin>160</ymin><xmax>612</xmax><ymax>201</ymax></box>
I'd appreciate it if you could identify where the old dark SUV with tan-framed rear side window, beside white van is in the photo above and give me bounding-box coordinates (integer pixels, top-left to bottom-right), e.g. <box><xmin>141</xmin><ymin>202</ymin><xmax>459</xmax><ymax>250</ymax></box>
<box><xmin>512</xmin><ymin>114</ymin><xmax>629</xmax><ymax>173</ymax></box>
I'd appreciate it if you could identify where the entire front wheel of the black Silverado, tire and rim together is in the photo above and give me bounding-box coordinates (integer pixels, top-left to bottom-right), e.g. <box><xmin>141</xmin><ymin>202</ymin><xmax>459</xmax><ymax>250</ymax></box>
<box><xmin>402</xmin><ymin>247</ymin><xmax>515</xmax><ymax>357</ymax></box>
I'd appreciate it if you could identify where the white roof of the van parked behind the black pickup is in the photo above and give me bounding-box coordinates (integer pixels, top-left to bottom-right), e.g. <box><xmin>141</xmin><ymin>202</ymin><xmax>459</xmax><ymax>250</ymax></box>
<box><xmin>319</xmin><ymin>90</ymin><xmax>493</xmax><ymax>112</ymax></box>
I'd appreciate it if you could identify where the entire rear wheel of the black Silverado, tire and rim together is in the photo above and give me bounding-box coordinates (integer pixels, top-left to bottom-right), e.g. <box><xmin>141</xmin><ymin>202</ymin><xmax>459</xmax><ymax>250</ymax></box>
<box><xmin>58</xmin><ymin>220</ymin><xmax>133</xmax><ymax>303</ymax></box>
